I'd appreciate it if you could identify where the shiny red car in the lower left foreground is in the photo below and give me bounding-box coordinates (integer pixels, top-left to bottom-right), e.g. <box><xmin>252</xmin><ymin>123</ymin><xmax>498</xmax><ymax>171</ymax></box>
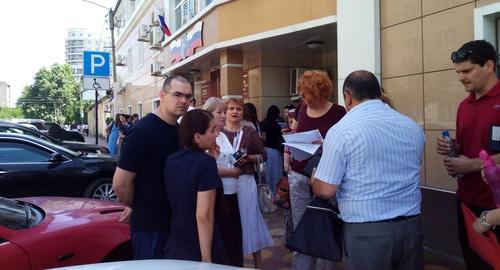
<box><xmin>0</xmin><ymin>197</ymin><xmax>132</xmax><ymax>269</ymax></box>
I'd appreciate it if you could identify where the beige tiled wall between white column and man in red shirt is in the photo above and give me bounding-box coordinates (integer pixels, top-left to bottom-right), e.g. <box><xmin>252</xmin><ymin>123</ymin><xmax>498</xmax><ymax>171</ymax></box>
<box><xmin>380</xmin><ymin>0</ymin><xmax>499</xmax><ymax>190</ymax></box>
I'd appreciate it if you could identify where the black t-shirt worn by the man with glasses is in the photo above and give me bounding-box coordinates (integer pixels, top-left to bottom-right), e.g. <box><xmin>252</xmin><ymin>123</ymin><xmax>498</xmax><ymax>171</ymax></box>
<box><xmin>118</xmin><ymin>113</ymin><xmax>179</xmax><ymax>233</ymax></box>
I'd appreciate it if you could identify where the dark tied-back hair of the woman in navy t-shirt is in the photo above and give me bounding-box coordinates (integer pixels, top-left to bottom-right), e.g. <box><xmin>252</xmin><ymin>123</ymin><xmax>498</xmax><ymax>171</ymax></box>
<box><xmin>179</xmin><ymin>109</ymin><xmax>213</xmax><ymax>151</ymax></box>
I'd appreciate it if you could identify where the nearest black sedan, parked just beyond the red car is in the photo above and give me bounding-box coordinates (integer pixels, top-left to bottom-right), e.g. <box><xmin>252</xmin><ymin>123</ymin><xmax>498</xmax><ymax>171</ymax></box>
<box><xmin>0</xmin><ymin>133</ymin><xmax>117</xmax><ymax>200</ymax></box>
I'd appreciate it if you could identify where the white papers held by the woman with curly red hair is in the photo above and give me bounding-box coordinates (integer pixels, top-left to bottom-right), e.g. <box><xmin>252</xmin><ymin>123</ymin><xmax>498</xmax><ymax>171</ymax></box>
<box><xmin>283</xmin><ymin>129</ymin><xmax>323</xmax><ymax>161</ymax></box>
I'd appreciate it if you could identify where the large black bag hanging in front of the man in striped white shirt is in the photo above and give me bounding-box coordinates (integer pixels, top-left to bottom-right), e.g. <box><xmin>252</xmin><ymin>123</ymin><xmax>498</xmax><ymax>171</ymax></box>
<box><xmin>286</xmin><ymin>197</ymin><xmax>343</xmax><ymax>262</ymax></box>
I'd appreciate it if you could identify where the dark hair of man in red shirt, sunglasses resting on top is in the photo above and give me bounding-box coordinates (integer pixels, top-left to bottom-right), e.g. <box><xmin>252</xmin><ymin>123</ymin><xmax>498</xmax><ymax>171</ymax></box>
<box><xmin>451</xmin><ymin>40</ymin><xmax>497</xmax><ymax>69</ymax></box>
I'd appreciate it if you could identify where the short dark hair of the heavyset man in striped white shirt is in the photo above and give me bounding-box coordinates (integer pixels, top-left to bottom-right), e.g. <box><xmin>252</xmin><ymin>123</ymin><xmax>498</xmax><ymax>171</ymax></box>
<box><xmin>342</xmin><ymin>70</ymin><xmax>382</xmax><ymax>100</ymax></box>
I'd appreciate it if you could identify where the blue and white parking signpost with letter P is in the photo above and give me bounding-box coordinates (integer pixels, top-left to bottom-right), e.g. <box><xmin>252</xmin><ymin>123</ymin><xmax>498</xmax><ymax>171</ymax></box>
<box><xmin>83</xmin><ymin>51</ymin><xmax>110</xmax><ymax>144</ymax></box>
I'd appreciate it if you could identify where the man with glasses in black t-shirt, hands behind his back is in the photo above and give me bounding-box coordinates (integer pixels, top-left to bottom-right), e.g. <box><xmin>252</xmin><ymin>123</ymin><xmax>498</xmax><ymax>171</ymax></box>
<box><xmin>113</xmin><ymin>76</ymin><xmax>193</xmax><ymax>259</ymax></box>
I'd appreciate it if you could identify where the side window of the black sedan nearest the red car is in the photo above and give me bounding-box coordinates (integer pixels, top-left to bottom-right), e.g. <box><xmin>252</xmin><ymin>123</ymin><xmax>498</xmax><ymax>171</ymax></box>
<box><xmin>0</xmin><ymin>142</ymin><xmax>50</xmax><ymax>164</ymax></box>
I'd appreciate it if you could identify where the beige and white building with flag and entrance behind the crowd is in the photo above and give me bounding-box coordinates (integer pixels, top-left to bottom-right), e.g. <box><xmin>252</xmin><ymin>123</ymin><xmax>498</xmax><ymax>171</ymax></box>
<box><xmin>89</xmin><ymin>0</ymin><xmax>500</xmax><ymax>261</ymax></box>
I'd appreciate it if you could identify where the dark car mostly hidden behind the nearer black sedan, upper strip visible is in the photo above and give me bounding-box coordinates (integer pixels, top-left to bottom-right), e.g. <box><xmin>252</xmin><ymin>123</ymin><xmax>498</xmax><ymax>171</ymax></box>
<box><xmin>0</xmin><ymin>121</ymin><xmax>109</xmax><ymax>154</ymax></box>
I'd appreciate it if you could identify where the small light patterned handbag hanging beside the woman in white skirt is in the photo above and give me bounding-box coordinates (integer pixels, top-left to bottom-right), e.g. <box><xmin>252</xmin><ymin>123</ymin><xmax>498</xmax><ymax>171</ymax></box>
<box><xmin>255</xmin><ymin>155</ymin><xmax>276</xmax><ymax>214</ymax></box>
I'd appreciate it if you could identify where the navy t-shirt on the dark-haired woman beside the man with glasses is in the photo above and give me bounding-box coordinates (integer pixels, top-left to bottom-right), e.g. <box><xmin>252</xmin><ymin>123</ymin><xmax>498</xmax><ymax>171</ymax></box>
<box><xmin>164</xmin><ymin>149</ymin><xmax>227</xmax><ymax>263</ymax></box>
